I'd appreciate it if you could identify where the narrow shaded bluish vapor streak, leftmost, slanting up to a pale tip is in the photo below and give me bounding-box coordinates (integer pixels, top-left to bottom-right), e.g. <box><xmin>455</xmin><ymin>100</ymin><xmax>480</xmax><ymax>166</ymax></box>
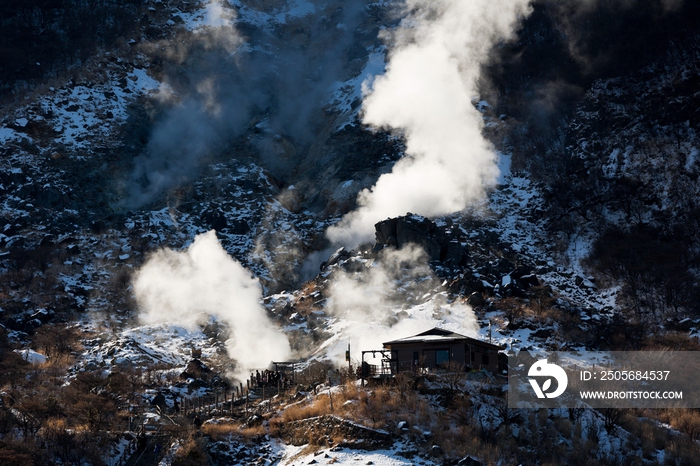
<box><xmin>121</xmin><ymin>0</ymin><xmax>249</xmax><ymax>209</ymax></box>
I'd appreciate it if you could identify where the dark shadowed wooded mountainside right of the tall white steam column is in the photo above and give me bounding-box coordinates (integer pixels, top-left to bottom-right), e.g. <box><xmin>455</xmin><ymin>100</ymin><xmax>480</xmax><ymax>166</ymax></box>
<box><xmin>482</xmin><ymin>2</ymin><xmax>700</xmax><ymax>322</ymax></box>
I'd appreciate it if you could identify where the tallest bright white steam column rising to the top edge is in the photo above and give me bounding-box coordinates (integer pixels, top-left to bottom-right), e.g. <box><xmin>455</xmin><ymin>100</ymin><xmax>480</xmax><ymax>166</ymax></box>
<box><xmin>328</xmin><ymin>0</ymin><xmax>528</xmax><ymax>247</ymax></box>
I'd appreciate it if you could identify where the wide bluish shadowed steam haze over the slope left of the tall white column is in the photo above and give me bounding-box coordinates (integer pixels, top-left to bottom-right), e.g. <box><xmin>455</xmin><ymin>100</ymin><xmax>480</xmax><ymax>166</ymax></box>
<box><xmin>123</xmin><ymin>0</ymin><xmax>366</xmax><ymax>208</ymax></box>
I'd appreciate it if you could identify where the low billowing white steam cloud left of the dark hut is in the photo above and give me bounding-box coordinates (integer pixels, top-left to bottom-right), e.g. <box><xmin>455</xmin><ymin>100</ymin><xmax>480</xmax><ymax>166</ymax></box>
<box><xmin>134</xmin><ymin>231</ymin><xmax>291</xmax><ymax>380</ymax></box>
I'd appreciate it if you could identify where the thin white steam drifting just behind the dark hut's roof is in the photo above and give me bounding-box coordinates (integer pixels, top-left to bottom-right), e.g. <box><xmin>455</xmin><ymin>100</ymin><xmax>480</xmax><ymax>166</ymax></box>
<box><xmin>322</xmin><ymin>245</ymin><xmax>479</xmax><ymax>365</ymax></box>
